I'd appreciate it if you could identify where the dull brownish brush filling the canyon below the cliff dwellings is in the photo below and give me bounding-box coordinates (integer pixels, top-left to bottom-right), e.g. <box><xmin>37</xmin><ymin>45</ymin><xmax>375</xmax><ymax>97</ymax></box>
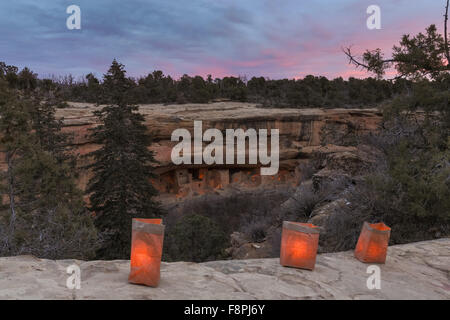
<box><xmin>164</xmin><ymin>187</ymin><xmax>293</xmax><ymax>261</ymax></box>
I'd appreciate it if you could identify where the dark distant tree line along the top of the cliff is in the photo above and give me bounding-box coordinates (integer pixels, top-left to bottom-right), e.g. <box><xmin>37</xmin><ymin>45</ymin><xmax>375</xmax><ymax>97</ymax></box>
<box><xmin>0</xmin><ymin>62</ymin><xmax>434</xmax><ymax>108</ymax></box>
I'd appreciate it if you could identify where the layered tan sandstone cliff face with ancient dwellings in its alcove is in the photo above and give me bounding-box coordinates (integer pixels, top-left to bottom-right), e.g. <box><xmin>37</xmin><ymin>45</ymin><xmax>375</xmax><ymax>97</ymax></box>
<box><xmin>57</xmin><ymin>102</ymin><xmax>381</xmax><ymax>199</ymax></box>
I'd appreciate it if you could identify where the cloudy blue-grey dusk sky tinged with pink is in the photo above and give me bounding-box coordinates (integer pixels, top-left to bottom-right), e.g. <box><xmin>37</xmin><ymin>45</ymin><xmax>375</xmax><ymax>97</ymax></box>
<box><xmin>0</xmin><ymin>0</ymin><xmax>445</xmax><ymax>79</ymax></box>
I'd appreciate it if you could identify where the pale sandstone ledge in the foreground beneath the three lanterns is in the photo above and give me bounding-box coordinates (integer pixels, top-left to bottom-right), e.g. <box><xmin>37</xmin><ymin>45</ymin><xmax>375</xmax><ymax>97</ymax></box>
<box><xmin>0</xmin><ymin>238</ymin><xmax>450</xmax><ymax>299</ymax></box>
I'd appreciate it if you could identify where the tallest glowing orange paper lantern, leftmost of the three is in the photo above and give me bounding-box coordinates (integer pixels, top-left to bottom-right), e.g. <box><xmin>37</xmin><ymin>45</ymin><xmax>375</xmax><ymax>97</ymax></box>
<box><xmin>128</xmin><ymin>219</ymin><xmax>164</xmax><ymax>287</ymax></box>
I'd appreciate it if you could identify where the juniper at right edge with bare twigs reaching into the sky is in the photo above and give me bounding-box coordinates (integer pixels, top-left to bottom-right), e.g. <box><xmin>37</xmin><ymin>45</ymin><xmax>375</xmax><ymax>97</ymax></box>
<box><xmin>341</xmin><ymin>0</ymin><xmax>450</xmax><ymax>242</ymax></box>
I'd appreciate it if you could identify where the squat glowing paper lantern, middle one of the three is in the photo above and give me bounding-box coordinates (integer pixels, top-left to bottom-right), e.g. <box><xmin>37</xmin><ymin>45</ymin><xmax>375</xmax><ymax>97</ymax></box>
<box><xmin>280</xmin><ymin>221</ymin><xmax>319</xmax><ymax>270</ymax></box>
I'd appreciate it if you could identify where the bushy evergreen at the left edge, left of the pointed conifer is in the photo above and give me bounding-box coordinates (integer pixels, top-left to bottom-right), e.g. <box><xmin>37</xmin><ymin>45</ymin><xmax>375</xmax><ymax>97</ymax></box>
<box><xmin>0</xmin><ymin>80</ymin><xmax>97</xmax><ymax>259</ymax></box>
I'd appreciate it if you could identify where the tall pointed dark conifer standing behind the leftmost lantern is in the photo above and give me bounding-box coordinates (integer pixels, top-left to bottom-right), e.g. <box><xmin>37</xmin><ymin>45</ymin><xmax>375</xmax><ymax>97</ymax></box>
<box><xmin>87</xmin><ymin>60</ymin><xmax>161</xmax><ymax>259</ymax></box>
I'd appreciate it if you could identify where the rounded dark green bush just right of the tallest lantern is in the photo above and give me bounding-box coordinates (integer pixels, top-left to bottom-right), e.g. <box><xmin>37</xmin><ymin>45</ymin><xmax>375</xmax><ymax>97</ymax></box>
<box><xmin>165</xmin><ymin>214</ymin><xmax>228</xmax><ymax>262</ymax></box>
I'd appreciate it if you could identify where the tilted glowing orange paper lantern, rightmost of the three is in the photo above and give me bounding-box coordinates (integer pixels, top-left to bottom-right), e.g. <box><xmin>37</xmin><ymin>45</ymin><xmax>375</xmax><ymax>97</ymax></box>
<box><xmin>355</xmin><ymin>222</ymin><xmax>391</xmax><ymax>263</ymax></box>
